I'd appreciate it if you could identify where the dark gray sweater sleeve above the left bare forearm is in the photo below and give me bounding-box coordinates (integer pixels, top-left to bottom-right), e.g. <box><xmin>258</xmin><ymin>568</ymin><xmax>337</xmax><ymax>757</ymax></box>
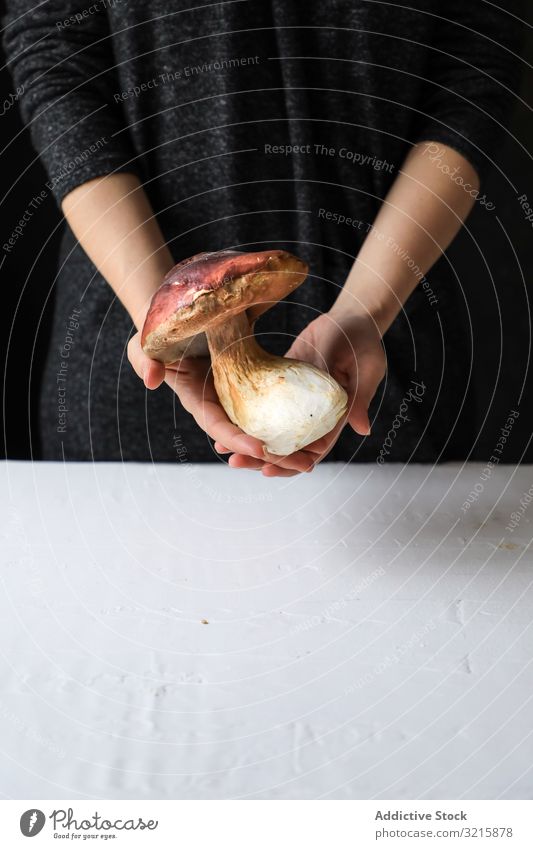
<box><xmin>3</xmin><ymin>0</ymin><xmax>137</xmax><ymax>203</ymax></box>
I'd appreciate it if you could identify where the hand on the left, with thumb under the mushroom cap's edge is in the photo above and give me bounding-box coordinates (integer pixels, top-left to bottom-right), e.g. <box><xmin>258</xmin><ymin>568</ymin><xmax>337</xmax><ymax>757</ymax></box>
<box><xmin>128</xmin><ymin>333</ymin><xmax>322</xmax><ymax>477</ymax></box>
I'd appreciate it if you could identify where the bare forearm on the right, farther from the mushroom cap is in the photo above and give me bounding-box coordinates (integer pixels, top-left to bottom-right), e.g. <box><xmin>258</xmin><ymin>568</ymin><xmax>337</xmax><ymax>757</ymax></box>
<box><xmin>332</xmin><ymin>142</ymin><xmax>479</xmax><ymax>334</ymax></box>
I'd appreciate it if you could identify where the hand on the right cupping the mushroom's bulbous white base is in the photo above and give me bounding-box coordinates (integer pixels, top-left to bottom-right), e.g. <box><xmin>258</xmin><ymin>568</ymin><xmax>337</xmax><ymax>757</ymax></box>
<box><xmin>222</xmin><ymin>307</ymin><xmax>386</xmax><ymax>477</ymax></box>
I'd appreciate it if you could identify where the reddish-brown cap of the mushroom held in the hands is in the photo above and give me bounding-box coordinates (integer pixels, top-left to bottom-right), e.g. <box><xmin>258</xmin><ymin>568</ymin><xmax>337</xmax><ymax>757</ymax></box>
<box><xmin>141</xmin><ymin>250</ymin><xmax>307</xmax><ymax>363</ymax></box>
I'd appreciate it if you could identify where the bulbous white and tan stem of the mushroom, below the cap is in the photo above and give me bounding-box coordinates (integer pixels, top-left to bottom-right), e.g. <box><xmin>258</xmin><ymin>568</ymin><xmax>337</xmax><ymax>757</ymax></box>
<box><xmin>206</xmin><ymin>312</ymin><xmax>348</xmax><ymax>456</ymax></box>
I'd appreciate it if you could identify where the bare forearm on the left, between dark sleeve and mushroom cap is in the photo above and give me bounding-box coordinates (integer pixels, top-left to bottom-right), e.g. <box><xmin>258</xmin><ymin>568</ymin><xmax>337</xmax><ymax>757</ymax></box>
<box><xmin>62</xmin><ymin>174</ymin><xmax>173</xmax><ymax>329</ymax></box>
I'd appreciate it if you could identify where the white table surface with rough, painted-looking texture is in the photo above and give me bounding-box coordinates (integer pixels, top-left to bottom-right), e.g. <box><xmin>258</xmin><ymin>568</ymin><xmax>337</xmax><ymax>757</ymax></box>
<box><xmin>0</xmin><ymin>462</ymin><xmax>533</xmax><ymax>799</ymax></box>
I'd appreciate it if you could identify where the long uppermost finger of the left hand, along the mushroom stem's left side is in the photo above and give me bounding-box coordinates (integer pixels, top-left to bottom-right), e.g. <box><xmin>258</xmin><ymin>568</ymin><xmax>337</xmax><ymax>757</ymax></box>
<box><xmin>165</xmin><ymin>370</ymin><xmax>264</xmax><ymax>460</ymax></box>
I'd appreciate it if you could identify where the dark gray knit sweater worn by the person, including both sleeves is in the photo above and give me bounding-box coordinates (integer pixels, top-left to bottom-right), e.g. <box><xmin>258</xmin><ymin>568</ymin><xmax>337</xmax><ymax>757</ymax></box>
<box><xmin>4</xmin><ymin>0</ymin><xmax>521</xmax><ymax>461</ymax></box>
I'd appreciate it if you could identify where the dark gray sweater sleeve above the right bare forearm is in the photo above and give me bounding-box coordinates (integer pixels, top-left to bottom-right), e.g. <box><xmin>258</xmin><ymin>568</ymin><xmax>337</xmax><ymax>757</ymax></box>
<box><xmin>415</xmin><ymin>0</ymin><xmax>523</xmax><ymax>179</ymax></box>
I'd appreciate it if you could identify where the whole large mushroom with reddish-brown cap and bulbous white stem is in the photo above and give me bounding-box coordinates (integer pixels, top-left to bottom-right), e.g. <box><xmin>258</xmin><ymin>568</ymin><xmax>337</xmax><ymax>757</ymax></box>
<box><xmin>141</xmin><ymin>250</ymin><xmax>347</xmax><ymax>455</ymax></box>
